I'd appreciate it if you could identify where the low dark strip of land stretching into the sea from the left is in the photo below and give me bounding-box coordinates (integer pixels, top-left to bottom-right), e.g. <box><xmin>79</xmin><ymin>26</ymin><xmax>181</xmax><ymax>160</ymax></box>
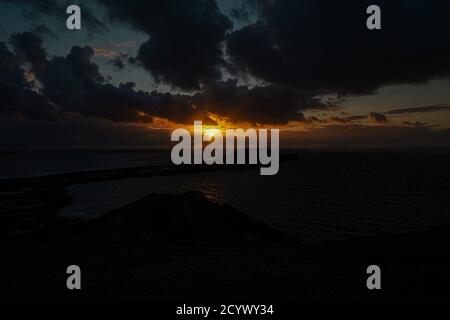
<box><xmin>0</xmin><ymin>154</ymin><xmax>298</xmax><ymax>240</ymax></box>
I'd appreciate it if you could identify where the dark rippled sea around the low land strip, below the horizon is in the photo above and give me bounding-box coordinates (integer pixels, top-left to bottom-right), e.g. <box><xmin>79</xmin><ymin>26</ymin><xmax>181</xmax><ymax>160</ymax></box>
<box><xmin>0</xmin><ymin>151</ymin><xmax>450</xmax><ymax>241</ymax></box>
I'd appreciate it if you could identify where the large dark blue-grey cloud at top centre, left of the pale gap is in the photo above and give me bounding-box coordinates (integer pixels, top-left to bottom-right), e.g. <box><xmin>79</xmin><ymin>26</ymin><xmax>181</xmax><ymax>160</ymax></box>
<box><xmin>98</xmin><ymin>0</ymin><xmax>232</xmax><ymax>90</ymax></box>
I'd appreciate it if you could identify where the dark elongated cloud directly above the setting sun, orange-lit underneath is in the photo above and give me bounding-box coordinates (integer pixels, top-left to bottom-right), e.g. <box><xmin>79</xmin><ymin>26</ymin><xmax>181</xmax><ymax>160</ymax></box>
<box><xmin>193</xmin><ymin>80</ymin><xmax>332</xmax><ymax>124</ymax></box>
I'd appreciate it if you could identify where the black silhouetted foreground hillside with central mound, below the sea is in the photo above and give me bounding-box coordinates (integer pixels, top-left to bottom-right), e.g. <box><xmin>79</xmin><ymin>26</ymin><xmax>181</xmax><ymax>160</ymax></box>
<box><xmin>0</xmin><ymin>193</ymin><xmax>450</xmax><ymax>301</ymax></box>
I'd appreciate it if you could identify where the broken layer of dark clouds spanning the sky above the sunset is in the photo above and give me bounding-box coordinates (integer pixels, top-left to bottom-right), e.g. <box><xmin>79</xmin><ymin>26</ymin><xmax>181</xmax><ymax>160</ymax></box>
<box><xmin>0</xmin><ymin>0</ymin><xmax>450</xmax><ymax>148</ymax></box>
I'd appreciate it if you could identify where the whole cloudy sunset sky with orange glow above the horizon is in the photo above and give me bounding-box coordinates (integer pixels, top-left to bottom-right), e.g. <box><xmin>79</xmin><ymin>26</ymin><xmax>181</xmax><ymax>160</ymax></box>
<box><xmin>0</xmin><ymin>0</ymin><xmax>450</xmax><ymax>149</ymax></box>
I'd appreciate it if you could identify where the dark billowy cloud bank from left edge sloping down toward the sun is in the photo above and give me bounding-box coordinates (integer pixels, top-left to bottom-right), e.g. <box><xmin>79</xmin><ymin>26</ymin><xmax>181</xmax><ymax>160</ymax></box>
<box><xmin>0</xmin><ymin>32</ymin><xmax>206</xmax><ymax>123</ymax></box>
